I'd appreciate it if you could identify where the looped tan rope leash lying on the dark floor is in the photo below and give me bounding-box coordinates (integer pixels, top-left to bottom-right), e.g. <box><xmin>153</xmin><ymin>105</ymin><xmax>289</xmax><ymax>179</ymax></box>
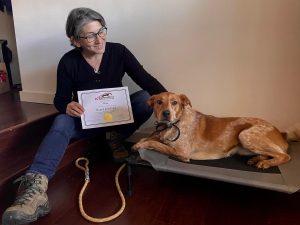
<box><xmin>75</xmin><ymin>157</ymin><xmax>126</xmax><ymax>223</ymax></box>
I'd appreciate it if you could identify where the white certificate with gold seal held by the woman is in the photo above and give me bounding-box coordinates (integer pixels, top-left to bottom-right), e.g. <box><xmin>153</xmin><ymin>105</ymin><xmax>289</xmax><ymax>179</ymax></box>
<box><xmin>78</xmin><ymin>87</ymin><xmax>133</xmax><ymax>129</ymax></box>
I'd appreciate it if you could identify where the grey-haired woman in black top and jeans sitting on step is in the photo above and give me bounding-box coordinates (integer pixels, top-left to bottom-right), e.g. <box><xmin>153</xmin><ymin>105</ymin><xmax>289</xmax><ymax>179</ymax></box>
<box><xmin>2</xmin><ymin>8</ymin><xmax>166</xmax><ymax>225</ymax></box>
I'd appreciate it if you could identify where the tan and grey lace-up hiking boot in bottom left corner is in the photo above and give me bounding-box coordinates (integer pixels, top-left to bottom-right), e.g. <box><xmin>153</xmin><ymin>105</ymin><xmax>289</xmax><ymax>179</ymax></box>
<box><xmin>2</xmin><ymin>173</ymin><xmax>50</xmax><ymax>225</ymax></box>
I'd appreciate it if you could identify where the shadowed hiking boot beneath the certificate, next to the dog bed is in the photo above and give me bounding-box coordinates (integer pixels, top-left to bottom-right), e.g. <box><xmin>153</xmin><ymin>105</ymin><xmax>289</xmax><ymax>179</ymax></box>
<box><xmin>106</xmin><ymin>131</ymin><xmax>129</xmax><ymax>162</ymax></box>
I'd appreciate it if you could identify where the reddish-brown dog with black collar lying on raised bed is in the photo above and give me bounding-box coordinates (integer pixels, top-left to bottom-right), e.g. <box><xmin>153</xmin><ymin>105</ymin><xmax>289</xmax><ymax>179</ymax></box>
<box><xmin>132</xmin><ymin>92</ymin><xmax>300</xmax><ymax>169</ymax></box>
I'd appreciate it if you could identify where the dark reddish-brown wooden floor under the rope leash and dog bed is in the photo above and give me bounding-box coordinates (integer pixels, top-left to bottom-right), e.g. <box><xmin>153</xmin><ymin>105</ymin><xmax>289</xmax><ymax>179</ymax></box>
<box><xmin>0</xmin><ymin>92</ymin><xmax>300</xmax><ymax>225</ymax></box>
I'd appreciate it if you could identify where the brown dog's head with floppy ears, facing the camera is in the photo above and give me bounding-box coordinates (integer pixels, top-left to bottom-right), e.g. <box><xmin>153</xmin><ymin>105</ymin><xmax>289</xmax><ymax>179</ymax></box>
<box><xmin>147</xmin><ymin>92</ymin><xmax>192</xmax><ymax>122</ymax></box>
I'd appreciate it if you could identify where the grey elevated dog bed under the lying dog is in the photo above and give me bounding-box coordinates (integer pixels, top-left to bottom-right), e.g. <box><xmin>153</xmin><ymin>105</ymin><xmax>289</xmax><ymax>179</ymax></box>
<box><xmin>128</xmin><ymin>142</ymin><xmax>300</xmax><ymax>194</ymax></box>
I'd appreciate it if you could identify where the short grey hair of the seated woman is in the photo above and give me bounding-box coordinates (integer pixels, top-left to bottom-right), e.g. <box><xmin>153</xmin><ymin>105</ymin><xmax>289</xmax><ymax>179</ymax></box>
<box><xmin>66</xmin><ymin>8</ymin><xmax>106</xmax><ymax>39</ymax></box>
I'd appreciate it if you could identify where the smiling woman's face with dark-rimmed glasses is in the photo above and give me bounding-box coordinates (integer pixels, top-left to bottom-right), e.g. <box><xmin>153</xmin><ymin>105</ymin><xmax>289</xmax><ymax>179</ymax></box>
<box><xmin>74</xmin><ymin>21</ymin><xmax>106</xmax><ymax>55</ymax></box>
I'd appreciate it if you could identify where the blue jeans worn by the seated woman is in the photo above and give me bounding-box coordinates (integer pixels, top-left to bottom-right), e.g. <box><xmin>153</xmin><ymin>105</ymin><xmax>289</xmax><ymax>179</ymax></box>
<box><xmin>27</xmin><ymin>90</ymin><xmax>153</xmax><ymax>179</ymax></box>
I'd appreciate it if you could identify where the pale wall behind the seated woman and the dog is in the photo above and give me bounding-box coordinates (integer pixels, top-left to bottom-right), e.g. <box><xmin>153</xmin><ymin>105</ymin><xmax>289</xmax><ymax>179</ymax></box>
<box><xmin>13</xmin><ymin>0</ymin><xmax>300</xmax><ymax>129</ymax></box>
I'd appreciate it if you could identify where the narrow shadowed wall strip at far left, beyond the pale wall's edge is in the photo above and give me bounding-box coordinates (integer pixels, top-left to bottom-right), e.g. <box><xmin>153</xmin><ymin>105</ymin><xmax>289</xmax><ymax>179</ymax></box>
<box><xmin>0</xmin><ymin>8</ymin><xmax>21</xmax><ymax>84</ymax></box>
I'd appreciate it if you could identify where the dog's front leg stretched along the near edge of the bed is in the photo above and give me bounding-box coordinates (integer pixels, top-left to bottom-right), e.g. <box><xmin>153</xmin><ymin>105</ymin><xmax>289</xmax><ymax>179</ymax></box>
<box><xmin>132</xmin><ymin>139</ymin><xmax>189</xmax><ymax>161</ymax></box>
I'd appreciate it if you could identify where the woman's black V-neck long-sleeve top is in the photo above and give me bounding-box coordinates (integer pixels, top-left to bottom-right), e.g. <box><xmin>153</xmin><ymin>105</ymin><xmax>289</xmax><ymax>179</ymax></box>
<box><xmin>54</xmin><ymin>42</ymin><xmax>166</xmax><ymax>113</ymax></box>
